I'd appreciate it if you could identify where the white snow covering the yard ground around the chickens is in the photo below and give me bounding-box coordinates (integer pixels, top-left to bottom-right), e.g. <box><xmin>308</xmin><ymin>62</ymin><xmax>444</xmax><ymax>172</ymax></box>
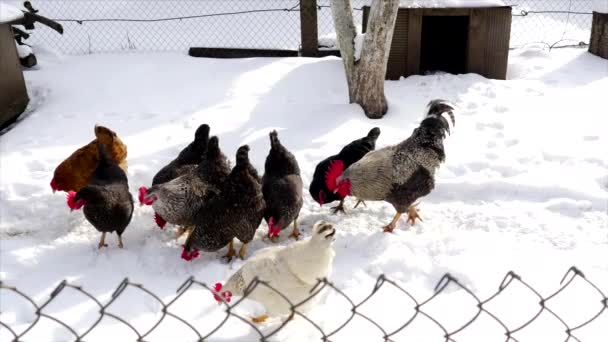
<box><xmin>0</xmin><ymin>47</ymin><xmax>608</xmax><ymax>341</ymax></box>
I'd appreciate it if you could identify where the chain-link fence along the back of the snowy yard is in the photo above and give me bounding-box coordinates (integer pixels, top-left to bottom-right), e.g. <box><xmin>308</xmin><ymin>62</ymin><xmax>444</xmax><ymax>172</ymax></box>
<box><xmin>14</xmin><ymin>0</ymin><xmax>593</xmax><ymax>54</ymax></box>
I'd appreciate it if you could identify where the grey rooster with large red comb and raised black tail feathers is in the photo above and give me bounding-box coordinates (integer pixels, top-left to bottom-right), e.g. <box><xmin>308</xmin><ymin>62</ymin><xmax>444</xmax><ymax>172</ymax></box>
<box><xmin>326</xmin><ymin>100</ymin><xmax>455</xmax><ymax>232</ymax></box>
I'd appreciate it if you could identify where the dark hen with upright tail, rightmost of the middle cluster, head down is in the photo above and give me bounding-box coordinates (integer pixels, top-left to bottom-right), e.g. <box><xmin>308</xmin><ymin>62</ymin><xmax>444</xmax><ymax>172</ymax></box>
<box><xmin>262</xmin><ymin>131</ymin><xmax>304</xmax><ymax>240</ymax></box>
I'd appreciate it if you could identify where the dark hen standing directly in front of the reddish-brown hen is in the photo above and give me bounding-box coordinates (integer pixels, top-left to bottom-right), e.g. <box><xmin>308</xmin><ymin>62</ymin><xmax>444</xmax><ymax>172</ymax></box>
<box><xmin>67</xmin><ymin>144</ymin><xmax>133</xmax><ymax>248</ymax></box>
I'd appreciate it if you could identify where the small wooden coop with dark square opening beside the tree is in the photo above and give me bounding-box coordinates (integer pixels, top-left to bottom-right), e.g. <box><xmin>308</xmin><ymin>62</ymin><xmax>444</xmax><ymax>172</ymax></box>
<box><xmin>363</xmin><ymin>2</ymin><xmax>511</xmax><ymax>80</ymax></box>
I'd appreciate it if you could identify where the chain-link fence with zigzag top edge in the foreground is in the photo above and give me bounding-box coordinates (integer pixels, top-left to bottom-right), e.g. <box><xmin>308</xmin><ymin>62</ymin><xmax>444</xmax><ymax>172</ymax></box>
<box><xmin>0</xmin><ymin>267</ymin><xmax>608</xmax><ymax>342</ymax></box>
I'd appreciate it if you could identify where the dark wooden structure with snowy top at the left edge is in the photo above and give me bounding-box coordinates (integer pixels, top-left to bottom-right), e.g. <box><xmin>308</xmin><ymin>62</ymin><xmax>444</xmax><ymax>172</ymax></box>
<box><xmin>0</xmin><ymin>3</ymin><xmax>30</xmax><ymax>129</ymax></box>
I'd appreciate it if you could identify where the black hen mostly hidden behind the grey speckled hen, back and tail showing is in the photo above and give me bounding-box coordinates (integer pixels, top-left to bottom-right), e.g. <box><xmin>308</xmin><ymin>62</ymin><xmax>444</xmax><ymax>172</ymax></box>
<box><xmin>152</xmin><ymin>124</ymin><xmax>209</xmax><ymax>186</ymax></box>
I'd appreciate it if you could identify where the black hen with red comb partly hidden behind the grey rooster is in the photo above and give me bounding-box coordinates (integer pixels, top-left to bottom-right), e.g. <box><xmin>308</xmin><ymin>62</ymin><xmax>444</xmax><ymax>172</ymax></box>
<box><xmin>308</xmin><ymin>127</ymin><xmax>380</xmax><ymax>213</ymax></box>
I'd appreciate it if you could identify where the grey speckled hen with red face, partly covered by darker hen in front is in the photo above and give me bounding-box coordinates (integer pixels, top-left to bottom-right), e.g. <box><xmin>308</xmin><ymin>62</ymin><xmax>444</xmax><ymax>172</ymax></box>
<box><xmin>141</xmin><ymin>136</ymin><xmax>230</xmax><ymax>236</ymax></box>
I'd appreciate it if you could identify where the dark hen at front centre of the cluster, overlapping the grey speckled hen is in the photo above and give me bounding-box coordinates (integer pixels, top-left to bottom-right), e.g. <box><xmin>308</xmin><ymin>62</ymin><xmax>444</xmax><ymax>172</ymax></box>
<box><xmin>182</xmin><ymin>145</ymin><xmax>265</xmax><ymax>260</ymax></box>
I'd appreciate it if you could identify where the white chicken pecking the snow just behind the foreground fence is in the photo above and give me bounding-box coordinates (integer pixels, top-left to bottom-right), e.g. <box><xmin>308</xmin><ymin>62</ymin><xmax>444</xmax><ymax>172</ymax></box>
<box><xmin>215</xmin><ymin>221</ymin><xmax>336</xmax><ymax>323</ymax></box>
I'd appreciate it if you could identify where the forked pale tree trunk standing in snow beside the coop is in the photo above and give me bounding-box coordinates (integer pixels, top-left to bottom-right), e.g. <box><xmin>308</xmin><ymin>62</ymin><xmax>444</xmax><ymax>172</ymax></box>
<box><xmin>331</xmin><ymin>0</ymin><xmax>399</xmax><ymax>119</ymax></box>
